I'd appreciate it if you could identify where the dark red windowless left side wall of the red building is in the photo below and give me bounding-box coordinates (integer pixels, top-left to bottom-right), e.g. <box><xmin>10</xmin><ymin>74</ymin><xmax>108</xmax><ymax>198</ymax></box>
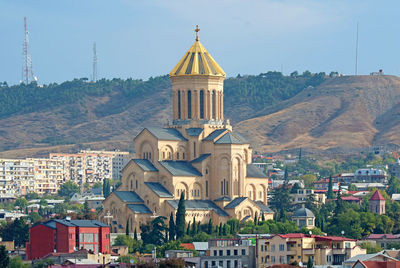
<box><xmin>26</xmin><ymin>224</ymin><xmax>56</xmax><ymax>260</ymax></box>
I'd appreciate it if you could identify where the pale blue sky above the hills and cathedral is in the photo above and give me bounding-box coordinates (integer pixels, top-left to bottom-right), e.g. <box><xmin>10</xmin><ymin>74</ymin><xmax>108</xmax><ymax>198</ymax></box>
<box><xmin>0</xmin><ymin>0</ymin><xmax>400</xmax><ymax>84</ymax></box>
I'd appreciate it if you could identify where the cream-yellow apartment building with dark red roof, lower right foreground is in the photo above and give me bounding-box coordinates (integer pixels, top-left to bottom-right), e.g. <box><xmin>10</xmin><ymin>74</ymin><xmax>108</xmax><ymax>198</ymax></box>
<box><xmin>257</xmin><ymin>233</ymin><xmax>366</xmax><ymax>267</ymax></box>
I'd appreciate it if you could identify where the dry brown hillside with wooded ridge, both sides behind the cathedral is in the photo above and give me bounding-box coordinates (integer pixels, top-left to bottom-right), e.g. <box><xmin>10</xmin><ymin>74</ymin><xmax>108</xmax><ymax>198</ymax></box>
<box><xmin>0</xmin><ymin>72</ymin><xmax>400</xmax><ymax>157</ymax></box>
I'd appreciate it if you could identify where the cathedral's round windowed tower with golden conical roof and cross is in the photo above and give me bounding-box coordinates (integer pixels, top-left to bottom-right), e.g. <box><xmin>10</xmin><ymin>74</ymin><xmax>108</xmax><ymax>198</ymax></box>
<box><xmin>169</xmin><ymin>25</ymin><xmax>226</xmax><ymax>125</ymax></box>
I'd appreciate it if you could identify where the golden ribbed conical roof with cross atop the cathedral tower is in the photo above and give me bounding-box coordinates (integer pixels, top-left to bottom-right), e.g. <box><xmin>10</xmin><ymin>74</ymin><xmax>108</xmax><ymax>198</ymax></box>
<box><xmin>169</xmin><ymin>27</ymin><xmax>226</xmax><ymax>77</ymax></box>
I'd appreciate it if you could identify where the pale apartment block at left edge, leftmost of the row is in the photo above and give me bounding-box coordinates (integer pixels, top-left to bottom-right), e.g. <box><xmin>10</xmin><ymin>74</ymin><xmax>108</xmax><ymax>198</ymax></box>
<box><xmin>0</xmin><ymin>159</ymin><xmax>35</xmax><ymax>196</ymax></box>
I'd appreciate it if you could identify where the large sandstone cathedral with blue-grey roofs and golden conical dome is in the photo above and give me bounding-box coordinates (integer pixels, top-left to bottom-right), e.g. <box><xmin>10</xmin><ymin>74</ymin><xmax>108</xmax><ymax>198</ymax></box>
<box><xmin>100</xmin><ymin>27</ymin><xmax>273</xmax><ymax>232</ymax></box>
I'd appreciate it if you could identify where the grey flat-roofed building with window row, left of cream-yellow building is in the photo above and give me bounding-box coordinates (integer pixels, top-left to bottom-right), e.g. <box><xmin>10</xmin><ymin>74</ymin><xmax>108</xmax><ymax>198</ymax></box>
<box><xmin>200</xmin><ymin>238</ymin><xmax>256</xmax><ymax>268</ymax></box>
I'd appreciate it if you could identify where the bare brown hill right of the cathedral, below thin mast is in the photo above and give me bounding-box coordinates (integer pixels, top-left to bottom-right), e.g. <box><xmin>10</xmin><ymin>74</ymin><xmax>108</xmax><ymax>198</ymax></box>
<box><xmin>236</xmin><ymin>76</ymin><xmax>400</xmax><ymax>152</ymax></box>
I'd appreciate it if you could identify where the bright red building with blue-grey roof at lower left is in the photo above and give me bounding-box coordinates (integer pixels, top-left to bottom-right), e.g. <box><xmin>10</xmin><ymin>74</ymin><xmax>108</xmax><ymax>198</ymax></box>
<box><xmin>26</xmin><ymin>218</ymin><xmax>111</xmax><ymax>260</ymax></box>
